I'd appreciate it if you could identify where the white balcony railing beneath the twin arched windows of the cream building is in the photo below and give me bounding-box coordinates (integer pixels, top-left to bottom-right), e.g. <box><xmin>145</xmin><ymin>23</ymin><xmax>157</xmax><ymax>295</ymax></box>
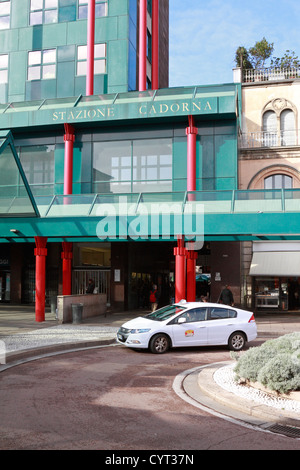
<box><xmin>239</xmin><ymin>129</ymin><xmax>300</xmax><ymax>149</ymax></box>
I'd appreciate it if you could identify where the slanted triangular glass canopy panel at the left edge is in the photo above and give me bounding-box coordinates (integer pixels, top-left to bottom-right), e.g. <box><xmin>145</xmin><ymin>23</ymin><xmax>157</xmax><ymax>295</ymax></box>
<box><xmin>0</xmin><ymin>141</ymin><xmax>37</xmax><ymax>217</ymax></box>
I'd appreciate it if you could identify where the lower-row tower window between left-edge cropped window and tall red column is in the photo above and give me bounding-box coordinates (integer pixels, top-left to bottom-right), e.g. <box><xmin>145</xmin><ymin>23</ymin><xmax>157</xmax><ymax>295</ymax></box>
<box><xmin>27</xmin><ymin>49</ymin><xmax>56</xmax><ymax>80</ymax></box>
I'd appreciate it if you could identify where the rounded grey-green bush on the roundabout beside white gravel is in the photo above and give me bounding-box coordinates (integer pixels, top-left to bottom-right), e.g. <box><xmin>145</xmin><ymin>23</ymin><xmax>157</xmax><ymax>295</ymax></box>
<box><xmin>234</xmin><ymin>333</ymin><xmax>300</xmax><ymax>393</ymax></box>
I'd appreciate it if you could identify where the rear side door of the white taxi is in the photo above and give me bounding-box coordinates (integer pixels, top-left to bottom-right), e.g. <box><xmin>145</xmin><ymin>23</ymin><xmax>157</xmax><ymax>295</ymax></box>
<box><xmin>207</xmin><ymin>306</ymin><xmax>237</xmax><ymax>345</ymax></box>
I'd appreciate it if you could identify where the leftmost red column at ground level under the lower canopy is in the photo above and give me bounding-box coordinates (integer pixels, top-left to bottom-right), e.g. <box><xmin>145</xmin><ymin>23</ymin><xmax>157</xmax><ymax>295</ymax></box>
<box><xmin>34</xmin><ymin>237</ymin><xmax>47</xmax><ymax>322</ymax></box>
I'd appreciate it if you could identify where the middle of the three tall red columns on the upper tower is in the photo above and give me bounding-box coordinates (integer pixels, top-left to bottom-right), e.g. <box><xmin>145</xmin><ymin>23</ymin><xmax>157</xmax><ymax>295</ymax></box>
<box><xmin>139</xmin><ymin>0</ymin><xmax>147</xmax><ymax>91</ymax></box>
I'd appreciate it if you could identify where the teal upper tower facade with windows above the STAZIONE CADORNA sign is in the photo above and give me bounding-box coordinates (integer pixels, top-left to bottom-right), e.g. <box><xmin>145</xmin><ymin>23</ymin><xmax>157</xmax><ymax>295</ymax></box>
<box><xmin>0</xmin><ymin>0</ymin><xmax>169</xmax><ymax>103</ymax></box>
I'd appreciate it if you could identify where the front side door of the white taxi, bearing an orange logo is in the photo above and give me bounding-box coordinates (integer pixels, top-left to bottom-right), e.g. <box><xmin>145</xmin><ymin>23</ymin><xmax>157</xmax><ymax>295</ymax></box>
<box><xmin>170</xmin><ymin>307</ymin><xmax>208</xmax><ymax>347</ymax></box>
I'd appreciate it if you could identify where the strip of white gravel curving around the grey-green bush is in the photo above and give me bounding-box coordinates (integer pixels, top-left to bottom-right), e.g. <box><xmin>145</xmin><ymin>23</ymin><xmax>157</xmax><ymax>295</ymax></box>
<box><xmin>214</xmin><ymin>364</ymin><xmax>300</xmax><ymax>414</ymax></box>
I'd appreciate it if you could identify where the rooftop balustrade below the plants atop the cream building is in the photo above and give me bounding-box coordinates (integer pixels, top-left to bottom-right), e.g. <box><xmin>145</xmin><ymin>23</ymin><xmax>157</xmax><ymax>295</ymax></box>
<box><xmin>243</xmin><ymin>67</ymin><xmax>300</xmax><ymax>83</ymax></box>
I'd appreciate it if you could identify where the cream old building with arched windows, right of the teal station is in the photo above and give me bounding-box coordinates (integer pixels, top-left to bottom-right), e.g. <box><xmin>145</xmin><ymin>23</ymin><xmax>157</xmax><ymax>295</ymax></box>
<box><xmin>239</xmin><ymin>69</ymin><xmax>300</xmax><ymax>311</ymax></box>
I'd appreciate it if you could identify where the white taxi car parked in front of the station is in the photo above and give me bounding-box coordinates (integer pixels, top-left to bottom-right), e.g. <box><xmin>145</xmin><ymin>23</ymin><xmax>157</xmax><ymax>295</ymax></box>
<box><xmin>117</xmin><ymin>301</ymin><xmax>257</xmax><ymax>354</ymax></box>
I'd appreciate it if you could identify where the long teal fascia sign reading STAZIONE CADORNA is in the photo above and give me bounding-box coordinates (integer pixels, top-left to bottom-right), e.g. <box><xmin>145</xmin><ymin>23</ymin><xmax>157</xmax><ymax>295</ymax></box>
<box><xmin>0</xmin><ymin>85</ymin><xmax>239</xmax><ymax>130</ymax></box>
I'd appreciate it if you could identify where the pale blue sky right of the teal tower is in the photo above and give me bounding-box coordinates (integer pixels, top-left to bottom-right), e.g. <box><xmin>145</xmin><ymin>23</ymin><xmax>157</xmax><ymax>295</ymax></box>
<box><xmin>169</xmin><ymin>0</ymin><xmax>300</xmax><ymax>87</ymax></box>
